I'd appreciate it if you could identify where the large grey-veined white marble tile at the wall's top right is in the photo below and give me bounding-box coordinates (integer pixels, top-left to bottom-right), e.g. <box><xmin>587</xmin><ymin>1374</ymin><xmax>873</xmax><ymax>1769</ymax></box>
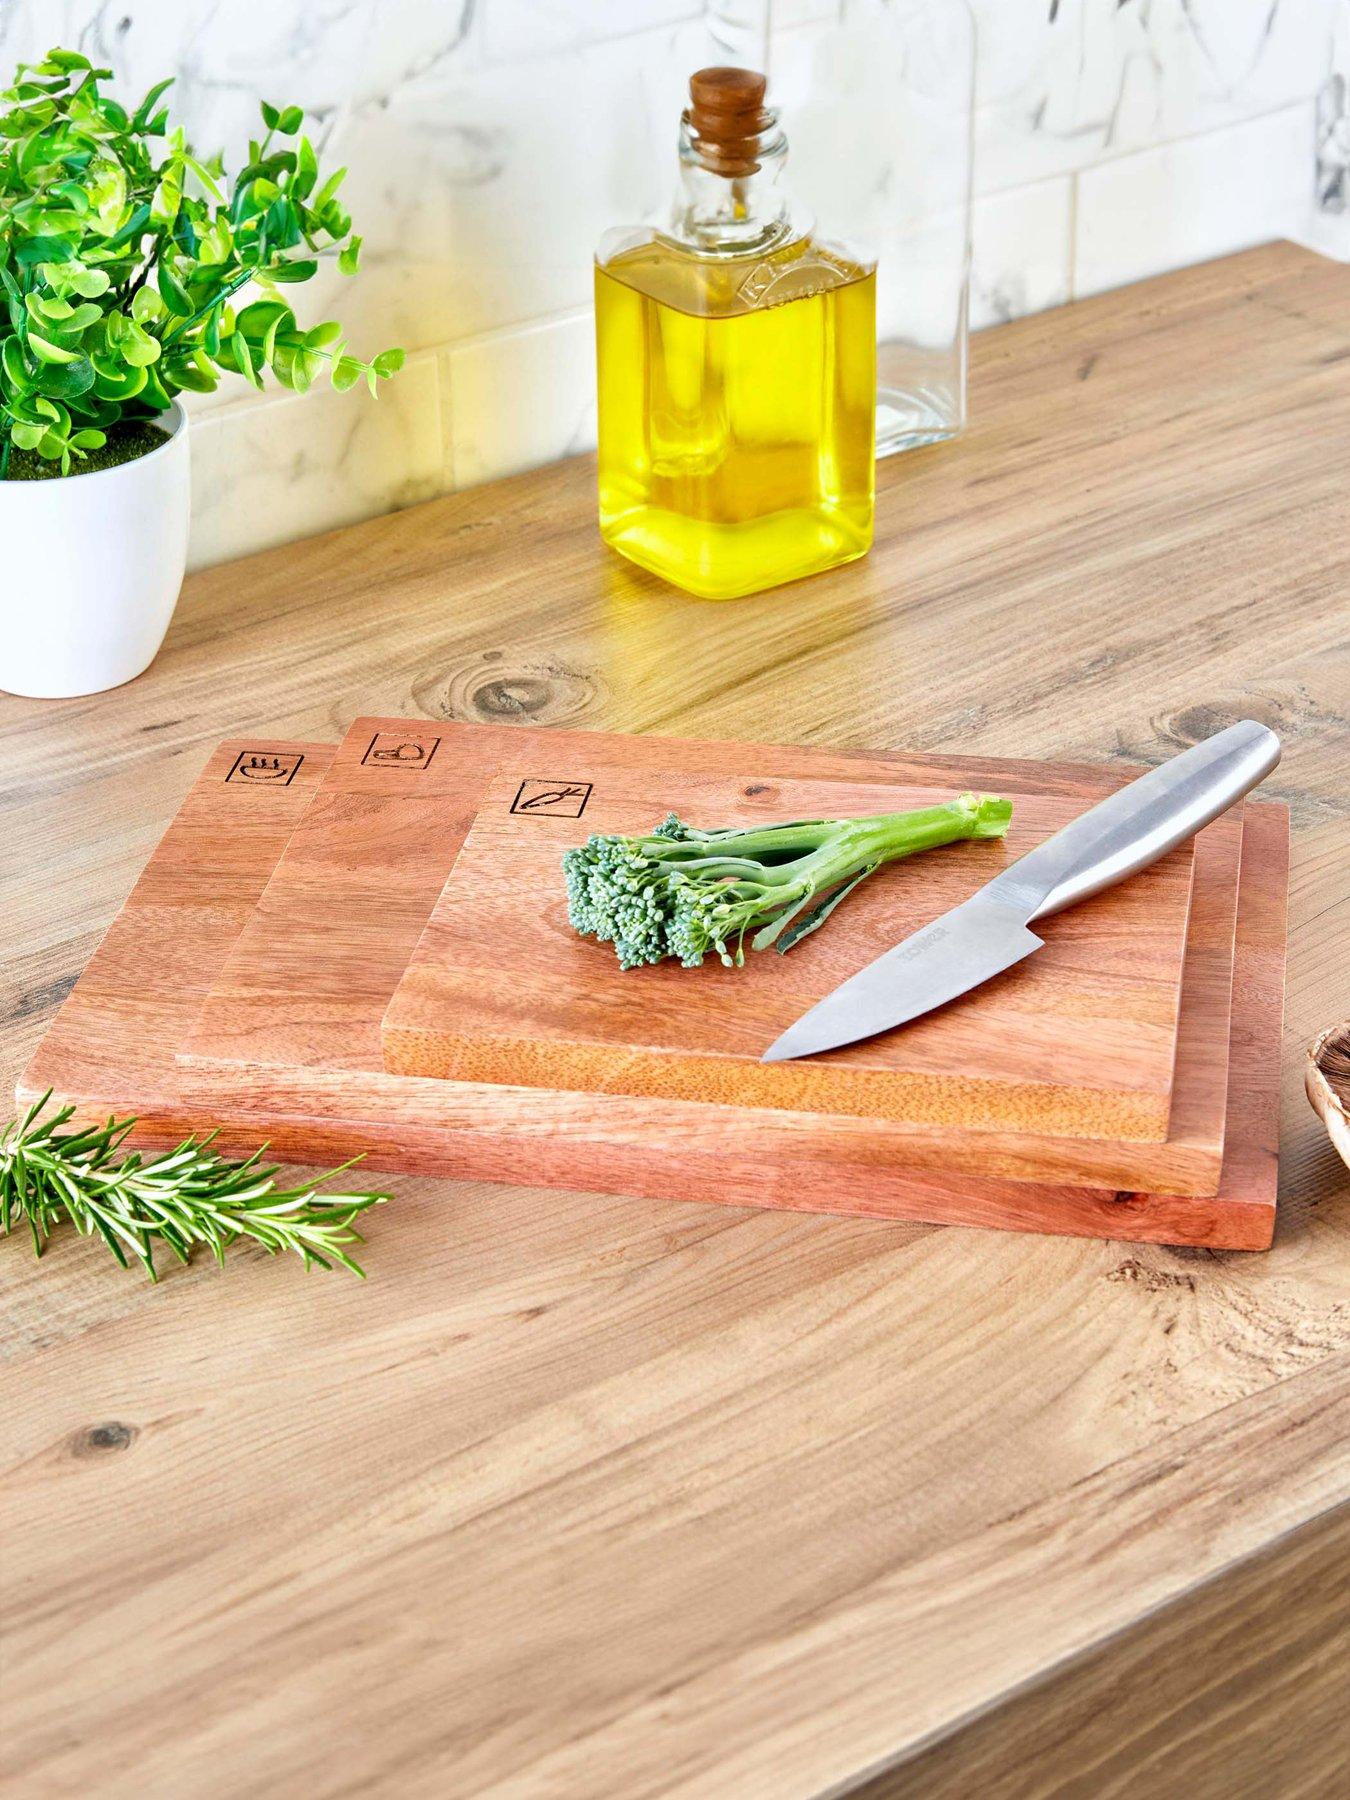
<box><xmin>976</xmin><ymin>0</ymin><xmax>1337</xmax><ymax>193</ymax></box>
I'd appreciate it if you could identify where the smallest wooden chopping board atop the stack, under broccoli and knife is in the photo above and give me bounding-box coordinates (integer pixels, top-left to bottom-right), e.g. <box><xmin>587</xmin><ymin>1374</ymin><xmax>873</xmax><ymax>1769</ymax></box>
<box><xmin>382</xmin><ymin>752</ymin><xmax>1195</xmax><ymax>1143</ymax></box>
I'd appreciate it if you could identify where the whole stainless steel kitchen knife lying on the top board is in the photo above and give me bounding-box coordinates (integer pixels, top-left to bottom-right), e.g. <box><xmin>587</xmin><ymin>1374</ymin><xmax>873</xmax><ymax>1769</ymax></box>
<box><xmin>763</xmin><ymin>718</ymin><xmax>1280</xmax><ymax>1062</ymax></box>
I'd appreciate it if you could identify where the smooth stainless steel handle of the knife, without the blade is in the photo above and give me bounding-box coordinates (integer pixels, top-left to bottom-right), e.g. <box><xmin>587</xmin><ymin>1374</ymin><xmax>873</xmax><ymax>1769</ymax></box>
<box><xmin>990</xmin><ymin>718</ymin><xmax>1280</xmax><ymax>922</ymax></box>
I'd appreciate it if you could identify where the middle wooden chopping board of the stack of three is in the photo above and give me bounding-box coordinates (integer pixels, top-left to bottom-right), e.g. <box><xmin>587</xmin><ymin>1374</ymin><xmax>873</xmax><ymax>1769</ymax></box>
<box><xmin>184</xmin><ymin>718</ymin><xmax>1242</xmax><ymax>1195</ymax></box>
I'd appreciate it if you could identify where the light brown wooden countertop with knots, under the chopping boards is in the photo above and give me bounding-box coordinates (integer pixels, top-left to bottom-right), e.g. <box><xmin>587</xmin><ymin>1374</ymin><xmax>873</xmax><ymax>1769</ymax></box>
<box><xmin>0</xmin><ymin>245</ymin><xmax>1350</xmax><ymax>1800</ymax></box>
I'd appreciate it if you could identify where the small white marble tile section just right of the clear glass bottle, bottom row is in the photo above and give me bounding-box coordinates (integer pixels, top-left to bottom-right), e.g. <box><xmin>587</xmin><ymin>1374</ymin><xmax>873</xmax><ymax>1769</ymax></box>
<box><xmin>970</xmin><ymin>176</ymin><xmax>1073</xmax><ymax>331</ymax></box>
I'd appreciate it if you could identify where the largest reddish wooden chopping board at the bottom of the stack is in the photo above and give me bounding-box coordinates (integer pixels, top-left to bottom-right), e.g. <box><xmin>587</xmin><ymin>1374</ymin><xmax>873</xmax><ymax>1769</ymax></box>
<box><xmin>18</xmin><ymin>743</ymin><xmax>1287</xmax><ymax>1249</ymax></box>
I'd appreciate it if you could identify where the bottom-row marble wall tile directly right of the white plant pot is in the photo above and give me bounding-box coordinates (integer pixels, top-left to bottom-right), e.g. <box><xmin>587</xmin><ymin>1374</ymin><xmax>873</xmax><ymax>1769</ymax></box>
<box><xmin>189</xmin><ymin>356</ymin><xmax>446</xmax><ymax>569</ymax></box>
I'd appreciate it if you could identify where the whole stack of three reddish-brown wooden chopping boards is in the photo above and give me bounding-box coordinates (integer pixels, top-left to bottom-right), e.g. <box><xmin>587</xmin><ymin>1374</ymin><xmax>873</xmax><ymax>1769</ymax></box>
<box><xmin>20</xmin><ymin>718</ymin><xmax>1287</xmax><ymax>1249</ymax></box>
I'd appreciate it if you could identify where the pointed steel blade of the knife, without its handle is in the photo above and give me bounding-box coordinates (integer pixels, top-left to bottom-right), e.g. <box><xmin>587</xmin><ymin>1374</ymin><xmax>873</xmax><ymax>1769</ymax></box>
<box><xmin>763</xmin><ymin>889</ymin><xmax>1044</xmax><ymax>1062</ymax></box>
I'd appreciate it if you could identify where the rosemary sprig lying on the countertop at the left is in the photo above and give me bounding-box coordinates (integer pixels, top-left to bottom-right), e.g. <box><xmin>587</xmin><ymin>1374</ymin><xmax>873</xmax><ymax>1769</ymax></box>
<box><xmin>0</xmin><ymin>1093</ymin><xmax>389</xmax><ymax>1282</ymax></box>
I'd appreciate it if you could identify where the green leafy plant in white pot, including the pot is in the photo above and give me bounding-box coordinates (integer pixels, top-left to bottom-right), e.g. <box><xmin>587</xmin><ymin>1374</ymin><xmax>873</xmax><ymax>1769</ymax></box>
<box><xmin>0</xmin><ymin>50</ymin><xmax>403</xmax><ymax>698</ymax></box>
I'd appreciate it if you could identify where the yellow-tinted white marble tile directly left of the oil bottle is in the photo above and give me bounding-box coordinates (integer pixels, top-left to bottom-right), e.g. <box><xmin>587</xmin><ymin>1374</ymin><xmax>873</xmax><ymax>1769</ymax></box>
<box><xmin>445</xmin><ymin>311</ymin><xmax>596</xmax><ymax>488</ymax></box>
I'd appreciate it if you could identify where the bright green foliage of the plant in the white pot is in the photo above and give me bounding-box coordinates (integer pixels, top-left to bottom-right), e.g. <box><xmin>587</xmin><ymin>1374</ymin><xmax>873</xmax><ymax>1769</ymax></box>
<box><xmin>0</xmin><ymin>49</ymin><xmax>403</xmax><ymax>477</ymax></box>
